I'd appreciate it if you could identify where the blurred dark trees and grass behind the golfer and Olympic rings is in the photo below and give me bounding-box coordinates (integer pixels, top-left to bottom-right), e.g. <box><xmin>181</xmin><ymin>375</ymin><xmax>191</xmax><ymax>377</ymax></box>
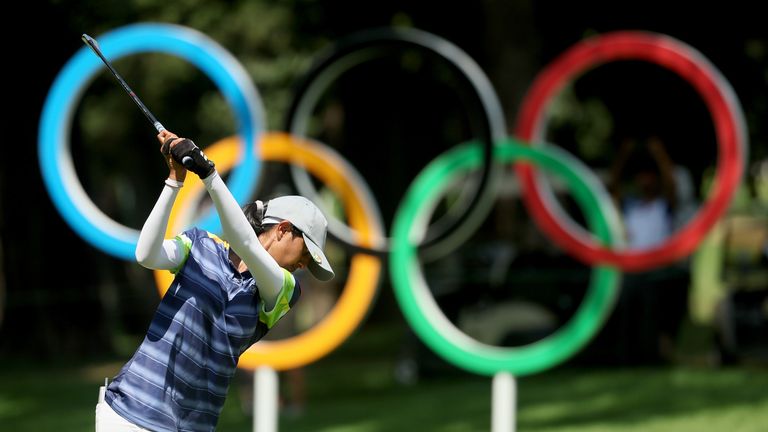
<box><xmin>0</xmin><ymin>0</ymin><xmax>768</xmax><ymax>431</ymax></box>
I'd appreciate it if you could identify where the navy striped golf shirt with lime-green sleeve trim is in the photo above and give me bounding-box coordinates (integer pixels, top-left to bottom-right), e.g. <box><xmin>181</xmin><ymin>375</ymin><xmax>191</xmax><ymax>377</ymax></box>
<box><xmin>105</xmin><ymin>228</ymin><xmax>301</xmax><ymax>431</ymax></box>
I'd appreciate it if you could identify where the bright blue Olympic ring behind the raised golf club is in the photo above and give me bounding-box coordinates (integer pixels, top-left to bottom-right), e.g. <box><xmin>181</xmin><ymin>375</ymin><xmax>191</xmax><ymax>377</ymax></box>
<box><xmin>38</xmin><ymin>24</ymin><xmax>265</xmax><ymax>260</ymax></box>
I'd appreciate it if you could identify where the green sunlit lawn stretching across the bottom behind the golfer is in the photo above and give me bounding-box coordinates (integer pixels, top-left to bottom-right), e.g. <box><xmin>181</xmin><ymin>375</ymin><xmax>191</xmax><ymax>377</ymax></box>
<box><xmin>0</xmin><ymin>324</ymin><xmax>768</xmax><ymax>432</ymax></box>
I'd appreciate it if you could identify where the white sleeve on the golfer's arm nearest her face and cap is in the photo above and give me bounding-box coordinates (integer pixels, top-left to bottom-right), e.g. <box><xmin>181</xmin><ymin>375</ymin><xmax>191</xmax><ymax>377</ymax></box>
<box><xmin>203</xmin><ymin>171</ymin><xmax>287</xmax><ymax>310</ymax></box>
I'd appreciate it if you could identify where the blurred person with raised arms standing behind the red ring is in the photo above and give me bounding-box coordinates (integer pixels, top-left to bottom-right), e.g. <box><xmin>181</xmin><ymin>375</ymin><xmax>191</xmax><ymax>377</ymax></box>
<box><xmin>593</xmin><ymin>136</ymin><xmax>696</xmax><ymax>365</ymax></box>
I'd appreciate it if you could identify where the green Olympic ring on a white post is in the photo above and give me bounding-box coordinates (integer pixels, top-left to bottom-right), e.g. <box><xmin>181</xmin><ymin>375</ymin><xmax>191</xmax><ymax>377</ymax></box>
<box><xmin>389</xmin><ymin>138</ymin><xmax>621</xmax><ymax>376</ymax></box>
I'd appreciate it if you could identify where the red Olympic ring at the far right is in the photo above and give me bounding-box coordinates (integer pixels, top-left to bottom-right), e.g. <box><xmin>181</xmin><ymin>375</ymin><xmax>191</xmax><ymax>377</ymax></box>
<box><xmin>515</xmin><ymin>31</ymin><xmax>747</xmax><ymax>271</ymax></box>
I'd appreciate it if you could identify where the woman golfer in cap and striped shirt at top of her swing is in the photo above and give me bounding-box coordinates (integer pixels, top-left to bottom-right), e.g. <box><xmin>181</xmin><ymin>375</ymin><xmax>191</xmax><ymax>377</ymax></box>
<box><xmin>96</xmin><ymin>131</ymin><xmax>333</xmax><ymax>432</ymax></box>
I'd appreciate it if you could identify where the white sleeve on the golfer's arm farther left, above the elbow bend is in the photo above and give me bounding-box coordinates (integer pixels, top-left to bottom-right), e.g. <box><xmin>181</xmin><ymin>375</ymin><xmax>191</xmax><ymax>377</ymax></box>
<box><xmin>136</xmin><ymin>185</ymin><xmax>184</xmax><ymax>270</ymax></box>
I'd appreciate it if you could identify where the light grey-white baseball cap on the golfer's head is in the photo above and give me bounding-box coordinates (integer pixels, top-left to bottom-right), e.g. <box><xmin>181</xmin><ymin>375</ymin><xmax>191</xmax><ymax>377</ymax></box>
<box><xmin>262</xmin><ymin>195</ymin><xmax>334</xmax><ymax>281</ymax></box>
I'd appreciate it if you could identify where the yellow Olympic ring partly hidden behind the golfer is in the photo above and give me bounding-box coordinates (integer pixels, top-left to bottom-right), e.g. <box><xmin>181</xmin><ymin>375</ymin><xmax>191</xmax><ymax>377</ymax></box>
<box><xmin>154</xmin><ymin>132</ymin><xmax>382</xmax><ymax>370</ymax></box>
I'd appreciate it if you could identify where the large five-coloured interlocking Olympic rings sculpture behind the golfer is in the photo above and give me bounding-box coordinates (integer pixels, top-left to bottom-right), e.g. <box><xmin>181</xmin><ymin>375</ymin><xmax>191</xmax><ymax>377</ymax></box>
<box><xmin>39</xmin><ymin>25</ymin><xmax>747</xmax><ymax>375</ymax></box>
